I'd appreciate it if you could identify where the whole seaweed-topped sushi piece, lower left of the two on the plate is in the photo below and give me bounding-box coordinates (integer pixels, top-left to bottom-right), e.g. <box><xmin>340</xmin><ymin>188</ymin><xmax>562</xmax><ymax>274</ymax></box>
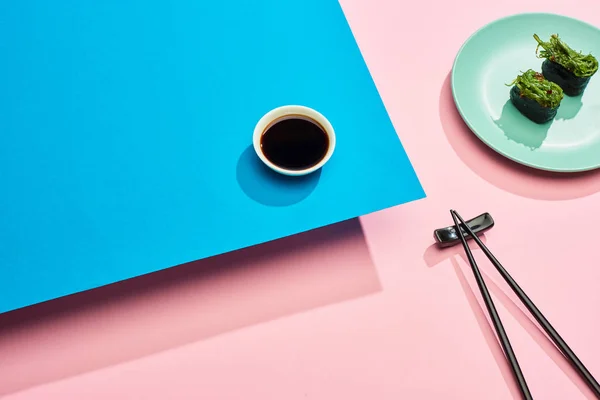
<box><xmin>509</xmin><ymin>69</ymin><xmax>564</xmax><ymax>124</ymax></box>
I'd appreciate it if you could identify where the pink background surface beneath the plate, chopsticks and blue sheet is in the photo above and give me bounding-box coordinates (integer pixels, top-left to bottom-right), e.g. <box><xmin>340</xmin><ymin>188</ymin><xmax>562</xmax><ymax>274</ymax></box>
<box><xmin>0</xmin><ymin>0</ymin><xmax>600</xmax><ymax>400</ymax></box>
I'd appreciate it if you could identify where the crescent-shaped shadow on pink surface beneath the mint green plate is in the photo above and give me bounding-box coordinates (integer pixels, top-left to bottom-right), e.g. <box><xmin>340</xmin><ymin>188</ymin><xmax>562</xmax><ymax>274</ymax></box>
<box><xmin>439</xmin><ymin>74</ymin><xmax>600</xmax><ymax>200</ymax></box>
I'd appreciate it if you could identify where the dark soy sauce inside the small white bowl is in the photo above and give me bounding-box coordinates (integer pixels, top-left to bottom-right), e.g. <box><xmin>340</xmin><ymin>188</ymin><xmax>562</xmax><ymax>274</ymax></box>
<box><xmin>260</xmin><ymin>115</ymin><xmax>329</xmax><ymax>170</ymax></box>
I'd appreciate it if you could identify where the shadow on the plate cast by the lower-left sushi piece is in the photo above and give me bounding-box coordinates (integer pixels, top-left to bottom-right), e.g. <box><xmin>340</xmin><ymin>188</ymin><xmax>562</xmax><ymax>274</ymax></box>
<box><xmin>493</xmin><ymin>100</ymin><xmax>558</xmax><ymax>150</ymax></box>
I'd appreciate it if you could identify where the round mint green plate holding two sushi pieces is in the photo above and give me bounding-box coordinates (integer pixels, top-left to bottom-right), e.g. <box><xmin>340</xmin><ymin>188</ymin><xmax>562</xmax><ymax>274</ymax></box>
<box><xmin>452</xmin><ymin>13</ymin><xmax>600</xmax><ymax>172</ymax></box>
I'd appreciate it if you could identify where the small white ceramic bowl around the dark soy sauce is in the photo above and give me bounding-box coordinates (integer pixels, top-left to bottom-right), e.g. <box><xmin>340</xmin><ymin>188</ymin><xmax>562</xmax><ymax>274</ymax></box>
<box><xmin>253</xmin><ymin>105</ymin><xmax>335</xmax><ymax>176</ymax></box>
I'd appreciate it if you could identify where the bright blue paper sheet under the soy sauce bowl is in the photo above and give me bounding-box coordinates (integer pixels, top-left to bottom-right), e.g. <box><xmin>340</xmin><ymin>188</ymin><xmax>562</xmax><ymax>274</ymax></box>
<box><xmin>0</xmin><ymin>0</ymin><xmax>424</xmax><ymax>312</ymax></box>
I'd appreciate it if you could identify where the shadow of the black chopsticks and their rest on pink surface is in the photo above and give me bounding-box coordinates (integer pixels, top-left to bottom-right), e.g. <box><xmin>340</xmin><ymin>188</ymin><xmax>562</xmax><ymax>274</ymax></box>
<box><xmin>423</xmin><ymin>242</ymin><xmax>596</xmax><ymax>400</ymax></box>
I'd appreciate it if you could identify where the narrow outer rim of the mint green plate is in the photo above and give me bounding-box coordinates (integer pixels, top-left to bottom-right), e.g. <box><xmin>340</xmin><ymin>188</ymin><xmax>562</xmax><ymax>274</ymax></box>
<box><xmin>450</xmin><ymin>12</ymin><xmax>600</xmax><ymax>174</ymax></box>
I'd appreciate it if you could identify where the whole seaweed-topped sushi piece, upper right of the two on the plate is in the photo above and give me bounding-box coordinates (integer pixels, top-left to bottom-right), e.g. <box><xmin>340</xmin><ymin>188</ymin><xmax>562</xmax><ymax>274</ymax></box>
<box><xmin>533</xmin><ymin>35</ymin><xmax>598</xmax><ymax>96</ymax></box>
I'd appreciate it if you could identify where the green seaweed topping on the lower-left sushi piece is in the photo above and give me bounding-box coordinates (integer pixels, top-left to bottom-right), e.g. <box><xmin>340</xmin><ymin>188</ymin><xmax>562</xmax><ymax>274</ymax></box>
<box><xmin>507</xmin><ymin>69</ymin><xmax>564</xmax><ymax>108</ymax></box>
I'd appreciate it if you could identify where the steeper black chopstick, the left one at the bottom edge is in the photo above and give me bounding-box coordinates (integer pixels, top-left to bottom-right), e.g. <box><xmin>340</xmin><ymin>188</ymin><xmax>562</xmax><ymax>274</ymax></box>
<box><xmin>450</xmin><ymin>210</ymin><xmax>533</xmax><ymax>400</ymax></box>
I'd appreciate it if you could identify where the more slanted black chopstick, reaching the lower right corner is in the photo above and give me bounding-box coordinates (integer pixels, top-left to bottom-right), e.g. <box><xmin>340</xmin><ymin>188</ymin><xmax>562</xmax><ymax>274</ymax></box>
<box><xmin>451</xmin><ymin>210</ymin><xmax>600</xmax><ymax>399</ymax></box>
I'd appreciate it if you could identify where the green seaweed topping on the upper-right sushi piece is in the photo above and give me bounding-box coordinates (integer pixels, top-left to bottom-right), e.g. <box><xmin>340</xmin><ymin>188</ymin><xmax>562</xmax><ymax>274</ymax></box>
<box><xmin>533</xmin><ymin>34</ymin><xmax>598</xmax><ymax>77</ymax></box>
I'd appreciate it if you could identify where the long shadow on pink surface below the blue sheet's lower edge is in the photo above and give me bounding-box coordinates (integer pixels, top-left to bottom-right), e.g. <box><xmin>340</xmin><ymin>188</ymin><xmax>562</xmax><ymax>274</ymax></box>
<box><xmin>0</xmin><ymin>219</ymin><xmax>381</xmax><ymax>397</ymax></box>
